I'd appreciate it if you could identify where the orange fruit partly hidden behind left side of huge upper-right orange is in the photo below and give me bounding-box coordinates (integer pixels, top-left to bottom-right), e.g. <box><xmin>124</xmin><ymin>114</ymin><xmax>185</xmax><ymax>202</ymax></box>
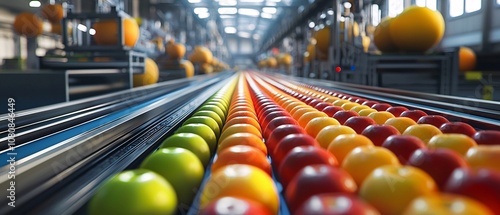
<box><xmin>373</xmin><ymin>17</ymin><xmax>398</xmax><ymax>52</ymax></box>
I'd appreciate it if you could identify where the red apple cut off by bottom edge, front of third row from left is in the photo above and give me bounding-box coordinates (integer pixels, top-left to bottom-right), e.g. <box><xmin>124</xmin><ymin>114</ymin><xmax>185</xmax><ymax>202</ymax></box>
<box><xmin>295</xmin><ymin>193</ymin><xmax>380</xmax><ymax>215</ymax></box>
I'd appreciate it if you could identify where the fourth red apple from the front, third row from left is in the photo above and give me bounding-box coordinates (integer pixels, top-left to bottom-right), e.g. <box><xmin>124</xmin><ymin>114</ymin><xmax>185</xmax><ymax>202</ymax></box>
<box><xmin>271</xmin><ymin>134</ymin><xmax>319</xmax><ymax>169</ymax></box>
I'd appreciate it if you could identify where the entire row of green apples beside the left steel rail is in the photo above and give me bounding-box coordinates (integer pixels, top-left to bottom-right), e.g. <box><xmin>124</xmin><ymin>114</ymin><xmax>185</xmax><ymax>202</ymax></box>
<box><xmin>88</xmin><ymin>76</ymin><xmax>235</xmax><ymax>215</ymax></box>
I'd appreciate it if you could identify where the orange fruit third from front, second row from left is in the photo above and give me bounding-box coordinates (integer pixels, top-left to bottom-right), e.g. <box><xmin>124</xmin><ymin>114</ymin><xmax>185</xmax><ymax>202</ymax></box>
<box><xmin>217</xmin><ymin>133</ymin><xmax>267</xmax><ymax>155</ymax></box>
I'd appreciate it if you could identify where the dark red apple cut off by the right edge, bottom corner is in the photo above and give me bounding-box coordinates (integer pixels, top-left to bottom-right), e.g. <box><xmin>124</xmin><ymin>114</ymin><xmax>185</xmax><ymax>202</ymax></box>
<box><xmin>444</xmin><ymin>168</ymin><xmax>500</xmax><ymax>214</ymax></box>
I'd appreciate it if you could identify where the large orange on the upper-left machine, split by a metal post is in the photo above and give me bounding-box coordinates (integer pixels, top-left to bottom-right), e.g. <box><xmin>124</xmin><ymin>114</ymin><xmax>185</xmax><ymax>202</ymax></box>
<box><xmin>92</xmin><ymin>18</ymin><xmax>139</xmax><ymax>47</ymax></box>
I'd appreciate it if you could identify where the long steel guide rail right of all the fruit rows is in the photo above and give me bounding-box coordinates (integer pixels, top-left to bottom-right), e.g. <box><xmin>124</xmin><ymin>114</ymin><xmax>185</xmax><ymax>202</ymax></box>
<box><xmin>274</xmin><ymin>75</ymin><xmax>500</xmax><ymax>130</ymax></box>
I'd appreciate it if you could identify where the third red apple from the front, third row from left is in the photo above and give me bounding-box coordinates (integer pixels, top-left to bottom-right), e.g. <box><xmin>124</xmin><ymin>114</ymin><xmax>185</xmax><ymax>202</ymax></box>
<box><xmin>278</xmin><ymin>146</ymin><xmax>339</xmax><ymax>189</ymax></box>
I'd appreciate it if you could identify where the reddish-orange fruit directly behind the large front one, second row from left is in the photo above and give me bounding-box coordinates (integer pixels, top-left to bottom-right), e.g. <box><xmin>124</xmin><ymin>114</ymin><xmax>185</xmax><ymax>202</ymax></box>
<box><xmin>212</xmin><ymin>145</ymin><xmax>271</xmax><ymax>175</ymax></box>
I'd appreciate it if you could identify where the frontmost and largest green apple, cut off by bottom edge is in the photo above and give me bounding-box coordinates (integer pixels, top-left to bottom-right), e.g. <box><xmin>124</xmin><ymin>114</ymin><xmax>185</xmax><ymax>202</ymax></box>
<box><xmin>88</xmin><ymin>169</ymin><xmax>177</xmax><ymax>215</ymax></box>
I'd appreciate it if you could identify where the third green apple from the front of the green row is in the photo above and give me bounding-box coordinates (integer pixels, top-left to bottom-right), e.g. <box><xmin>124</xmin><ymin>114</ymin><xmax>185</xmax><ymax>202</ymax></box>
<box><xmin>160</xmin><ymin>133</ymin><xmax>210</xmax><ymax>166</ymax></box>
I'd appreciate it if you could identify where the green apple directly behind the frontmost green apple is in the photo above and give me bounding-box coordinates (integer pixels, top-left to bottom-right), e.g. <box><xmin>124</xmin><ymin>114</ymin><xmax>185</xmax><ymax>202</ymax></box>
<box><xmin>141</xmin><ymin>147</ymin><xmax>205</xmax><ymax>208</ymax></box>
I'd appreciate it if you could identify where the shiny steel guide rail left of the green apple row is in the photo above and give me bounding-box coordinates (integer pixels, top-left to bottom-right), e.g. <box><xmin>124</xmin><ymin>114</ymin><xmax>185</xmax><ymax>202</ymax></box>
<box><xmin>0</xmin><ymin>72</ymin><xmax>234</xmax><ymax>214</ymax></box>
